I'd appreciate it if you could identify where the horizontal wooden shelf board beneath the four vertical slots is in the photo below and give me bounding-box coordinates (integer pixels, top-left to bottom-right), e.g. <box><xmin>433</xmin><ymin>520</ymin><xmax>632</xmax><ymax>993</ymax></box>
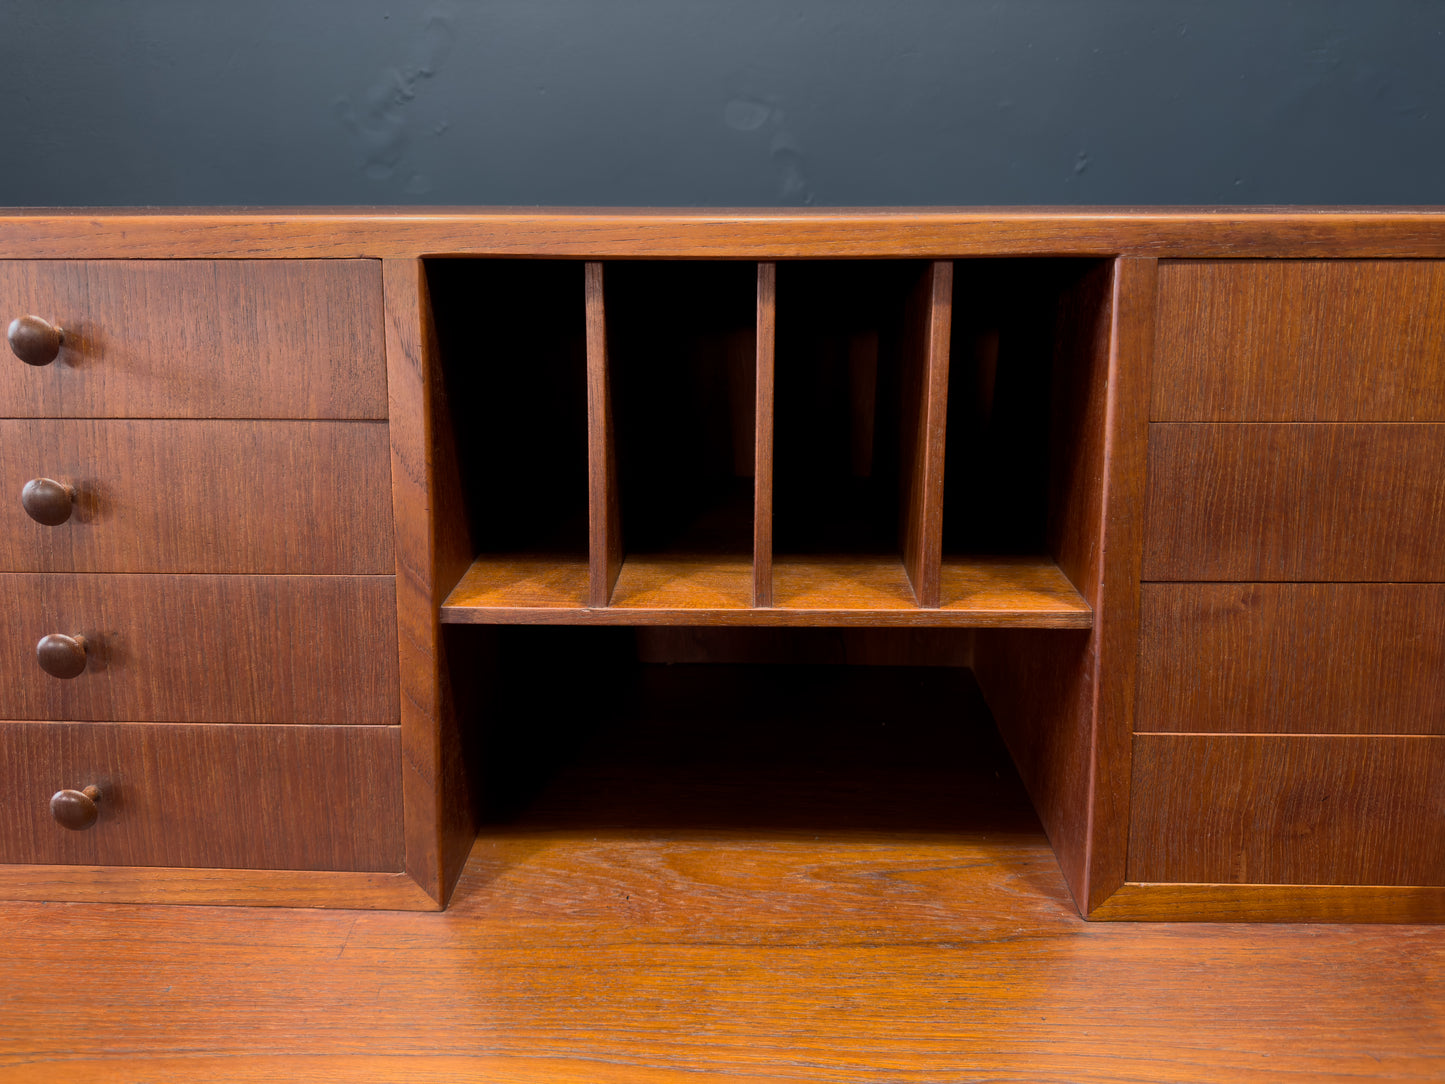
<box><xmin>441</xmin><ymin>555</ymin><xmax>1094</xmax><ymax>629</ymax></box>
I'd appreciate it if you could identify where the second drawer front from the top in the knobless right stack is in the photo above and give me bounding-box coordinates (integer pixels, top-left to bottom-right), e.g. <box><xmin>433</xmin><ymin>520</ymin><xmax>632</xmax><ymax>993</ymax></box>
<box><xmin>1143</xmin><ymin>422</ymin><xmax>1445</xmax><ymax>581</ymax></box>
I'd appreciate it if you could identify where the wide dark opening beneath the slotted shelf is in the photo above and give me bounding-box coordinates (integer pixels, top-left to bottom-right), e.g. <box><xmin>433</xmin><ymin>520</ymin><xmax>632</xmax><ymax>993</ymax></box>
<box><xmin>449</xmin><ymin>626</ymin><xmax>1039</xmax><ymax>846</ymax></box>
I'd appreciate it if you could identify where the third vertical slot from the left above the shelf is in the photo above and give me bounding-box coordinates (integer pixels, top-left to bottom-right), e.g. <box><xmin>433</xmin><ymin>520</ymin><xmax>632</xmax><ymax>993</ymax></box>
<box><xmin>772</xmin><ymin>260</ymin><xmax>951</xmax><ymax>613</ymax></box>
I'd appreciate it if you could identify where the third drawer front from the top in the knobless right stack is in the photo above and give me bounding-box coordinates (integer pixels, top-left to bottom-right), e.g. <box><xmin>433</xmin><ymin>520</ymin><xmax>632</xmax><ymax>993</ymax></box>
<box><xmin>1134</xmin><ymin>584</ymin><xmax>1445</xmax><ymax>734</ymax></box>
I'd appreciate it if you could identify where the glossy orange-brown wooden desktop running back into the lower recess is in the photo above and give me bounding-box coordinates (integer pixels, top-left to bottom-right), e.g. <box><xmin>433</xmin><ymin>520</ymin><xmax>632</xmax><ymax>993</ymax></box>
<box><xmin>0</xmin><ymin>668</ymin><xmax>1445</xmax><ymax>1084</ymax></box>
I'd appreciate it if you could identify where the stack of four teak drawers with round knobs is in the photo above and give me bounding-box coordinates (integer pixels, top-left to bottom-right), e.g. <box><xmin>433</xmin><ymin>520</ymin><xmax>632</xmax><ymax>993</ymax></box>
<box><xmin>0</xmin><ymin>260</ymin><xmax>403</xmax><ymax>872</ymax></box>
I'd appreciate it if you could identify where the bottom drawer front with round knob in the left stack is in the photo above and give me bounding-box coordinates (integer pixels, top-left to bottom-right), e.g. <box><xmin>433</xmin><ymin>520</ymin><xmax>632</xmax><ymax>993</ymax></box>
<box><xmin>0</xmin><ymin>723</ymin><xmax>402</xmax><ymax>872</ymax></box>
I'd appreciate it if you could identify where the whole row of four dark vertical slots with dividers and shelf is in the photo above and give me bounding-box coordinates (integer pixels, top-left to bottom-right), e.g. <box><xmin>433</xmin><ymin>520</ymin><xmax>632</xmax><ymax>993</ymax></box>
<box><xmin>428</xmin><ymin>259</ymin><xmax>1111</xmax><ymax>629</ymax></box>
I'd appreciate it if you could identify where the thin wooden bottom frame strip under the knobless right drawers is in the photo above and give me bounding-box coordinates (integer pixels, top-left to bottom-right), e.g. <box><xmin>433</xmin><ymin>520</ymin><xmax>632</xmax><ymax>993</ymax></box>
<box><xmin>1087</xmin><ymin>882</ymin><xmax>1445</xmax><ymax>924</ymax></box>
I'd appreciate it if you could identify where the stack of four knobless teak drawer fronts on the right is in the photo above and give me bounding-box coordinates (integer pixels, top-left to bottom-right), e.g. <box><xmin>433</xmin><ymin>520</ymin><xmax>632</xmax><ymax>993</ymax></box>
<box><xmin>1129</xmin><ymin>260</ymin><xmax>1445</xmax><ymax>885</ymax></box>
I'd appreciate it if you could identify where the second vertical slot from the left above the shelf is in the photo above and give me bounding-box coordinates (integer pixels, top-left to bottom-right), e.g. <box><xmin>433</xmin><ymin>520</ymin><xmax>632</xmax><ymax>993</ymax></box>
<box><xmin>587</xmin><ymin>262</ymin><xmax>759</xmax><ymax>610</ymax></box>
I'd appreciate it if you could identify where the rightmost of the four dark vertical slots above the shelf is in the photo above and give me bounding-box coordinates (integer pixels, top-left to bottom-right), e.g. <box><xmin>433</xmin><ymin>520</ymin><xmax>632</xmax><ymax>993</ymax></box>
<box><xmin>939</xmin><ymin>259</ymin><xmax>1111</xmax><ymax>627</ymax></box>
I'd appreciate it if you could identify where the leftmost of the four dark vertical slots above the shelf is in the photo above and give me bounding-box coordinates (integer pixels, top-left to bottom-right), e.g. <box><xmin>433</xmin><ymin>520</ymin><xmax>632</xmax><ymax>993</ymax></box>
<box><xmin>426</xmin><ymin>259</ymin><xmax>588</xmax><ymax>608</ymax></box>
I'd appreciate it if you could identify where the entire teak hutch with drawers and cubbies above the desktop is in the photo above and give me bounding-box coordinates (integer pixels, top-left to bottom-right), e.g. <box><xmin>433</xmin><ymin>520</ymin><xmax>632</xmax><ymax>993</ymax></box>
<box><xmin>0</xmin><ymin>210</ymin><xmax>1445</xmax><ymax>921</ymax></box>
